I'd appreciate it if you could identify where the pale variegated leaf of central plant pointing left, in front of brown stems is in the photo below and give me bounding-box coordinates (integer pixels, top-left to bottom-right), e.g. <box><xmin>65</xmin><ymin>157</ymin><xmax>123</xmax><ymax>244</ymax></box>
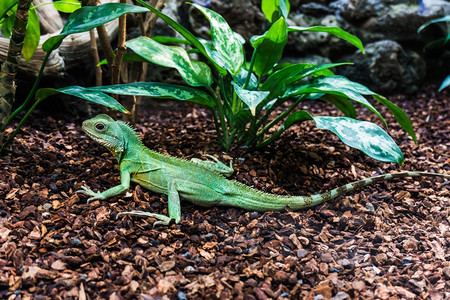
<box><xmin>126</xmin><ymin>37</ymin><xmax>213</xmax><ymax>86</ymax></box>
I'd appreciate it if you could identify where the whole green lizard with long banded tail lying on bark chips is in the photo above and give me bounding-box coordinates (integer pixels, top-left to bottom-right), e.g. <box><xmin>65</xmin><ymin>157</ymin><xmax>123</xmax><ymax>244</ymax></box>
<box><xmin>78</xmin><ymin>114</ymin><xmax>450</xmax><ymax>225</ymax></box>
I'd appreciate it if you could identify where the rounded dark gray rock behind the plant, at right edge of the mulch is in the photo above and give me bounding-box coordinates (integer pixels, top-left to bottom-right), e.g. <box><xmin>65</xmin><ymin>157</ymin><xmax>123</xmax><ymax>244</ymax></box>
<box><xmin>338</xmin><ymin>40</ymin><xmax>426</xmax><ymax>93</ymax></box>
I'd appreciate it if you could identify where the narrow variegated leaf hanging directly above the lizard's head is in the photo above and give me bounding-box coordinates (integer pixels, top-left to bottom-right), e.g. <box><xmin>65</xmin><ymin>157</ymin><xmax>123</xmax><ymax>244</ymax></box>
<box><xmin>36</xmin><ymin>86</ymin><xmax>130</xmax><ymax>114</ymax></box>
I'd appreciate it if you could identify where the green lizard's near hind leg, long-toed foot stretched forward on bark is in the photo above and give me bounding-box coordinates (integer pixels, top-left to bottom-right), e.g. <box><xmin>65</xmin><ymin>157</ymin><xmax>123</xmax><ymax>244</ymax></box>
<box><xmin>117</xmin><ymin>179</ymin><xmax>220</xmax><ymax>226</ymax></box>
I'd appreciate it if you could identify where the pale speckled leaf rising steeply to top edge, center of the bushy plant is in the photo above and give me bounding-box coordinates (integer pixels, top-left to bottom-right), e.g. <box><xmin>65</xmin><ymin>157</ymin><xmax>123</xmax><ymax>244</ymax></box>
<box><xmin>192</xmin><ymin>4</ymin><xmax>245</xmax><ymax>76</ymax></box>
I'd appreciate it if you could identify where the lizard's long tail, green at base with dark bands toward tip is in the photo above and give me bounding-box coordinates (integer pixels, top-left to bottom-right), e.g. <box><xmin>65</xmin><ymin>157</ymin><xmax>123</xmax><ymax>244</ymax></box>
<box><xmin>225</xmin><ymin>172</ymin><xmax>450</xmax><ymax>211</ymax></box>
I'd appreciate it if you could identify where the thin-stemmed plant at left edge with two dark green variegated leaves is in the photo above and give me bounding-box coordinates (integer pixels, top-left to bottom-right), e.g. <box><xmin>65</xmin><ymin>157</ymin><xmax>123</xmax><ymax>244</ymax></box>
<box><xmin>0</xmin><ymin>3</ymin><xmax>148</xmax><ymax>151</ymax></box>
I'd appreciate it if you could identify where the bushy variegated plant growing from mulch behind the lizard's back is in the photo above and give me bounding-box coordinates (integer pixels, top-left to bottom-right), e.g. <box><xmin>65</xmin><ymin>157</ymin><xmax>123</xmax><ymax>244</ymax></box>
<box><xmin>48</xmin><ymin>0</ymin><xmax>416</xmax><ymax>163</ymax></box>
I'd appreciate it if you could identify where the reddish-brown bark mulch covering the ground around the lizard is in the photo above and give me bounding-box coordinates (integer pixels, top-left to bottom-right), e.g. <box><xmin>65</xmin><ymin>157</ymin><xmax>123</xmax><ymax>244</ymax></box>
<box><xmin>0</xmin><ymin>87</ymin><xmax>450</xmax><ymax>300</ymax></box>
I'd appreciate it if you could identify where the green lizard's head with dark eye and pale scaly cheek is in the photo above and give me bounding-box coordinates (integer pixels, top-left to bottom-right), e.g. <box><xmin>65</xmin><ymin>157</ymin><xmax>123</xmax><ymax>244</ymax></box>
<box><xmin>83</xmin><ymin>114</ymin><xmax>127</xmax><ymax>156</ymax></box>
